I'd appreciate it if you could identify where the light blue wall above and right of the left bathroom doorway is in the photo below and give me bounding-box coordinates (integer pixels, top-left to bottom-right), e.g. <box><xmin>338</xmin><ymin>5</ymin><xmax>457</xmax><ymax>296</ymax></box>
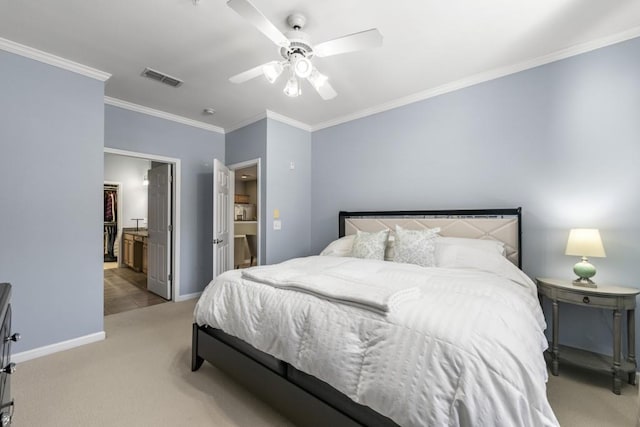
<box><xmin>104</xmin><ymin>105</ymin><xmax>225</xmax><ymax>295</ymax></box>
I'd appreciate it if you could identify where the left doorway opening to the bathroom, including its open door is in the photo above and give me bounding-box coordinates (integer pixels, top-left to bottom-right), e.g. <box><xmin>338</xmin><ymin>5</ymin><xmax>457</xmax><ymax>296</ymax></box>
<box><xmin>104</xmin><ymin>148</ymin><xmax>180</xmax><ymax>315</ymax></box>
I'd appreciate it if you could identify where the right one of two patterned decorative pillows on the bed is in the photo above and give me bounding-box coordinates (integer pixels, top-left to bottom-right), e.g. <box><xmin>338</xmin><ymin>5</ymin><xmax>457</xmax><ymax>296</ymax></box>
<box><xmin>393</xmin><ymin>225</ymin><xmax>440</xmax><ymax>267</ymax></box>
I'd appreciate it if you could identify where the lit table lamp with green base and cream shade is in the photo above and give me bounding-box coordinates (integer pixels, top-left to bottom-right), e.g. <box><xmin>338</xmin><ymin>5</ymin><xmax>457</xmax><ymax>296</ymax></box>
<box><xmin>564</xmin><ymin>228</ymin><xmax>607</xmax><ymax>288</ymax></box>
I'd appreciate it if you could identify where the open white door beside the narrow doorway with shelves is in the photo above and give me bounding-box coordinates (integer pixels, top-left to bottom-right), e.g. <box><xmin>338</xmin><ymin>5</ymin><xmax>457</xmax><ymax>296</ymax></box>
<box><xmin>213</xmin><ymin>159</ymin><xmax>233</xmax><ymax>278</ymax></box>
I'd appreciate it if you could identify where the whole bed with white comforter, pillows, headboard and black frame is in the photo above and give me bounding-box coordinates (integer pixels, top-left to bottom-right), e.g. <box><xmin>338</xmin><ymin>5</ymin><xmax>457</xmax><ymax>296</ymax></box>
<box><xmin>192</xmin><ymin>208</ymin><xmax>558</xmax><ymax>426</ymax></box>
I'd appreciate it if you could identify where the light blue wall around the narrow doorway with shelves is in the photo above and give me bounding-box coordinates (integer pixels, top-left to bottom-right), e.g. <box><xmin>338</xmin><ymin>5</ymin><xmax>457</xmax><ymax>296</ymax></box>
<box><xmin>225</xmin><ymin>119</ymin><xmax>267</xmax><ymax>264</ymax></box>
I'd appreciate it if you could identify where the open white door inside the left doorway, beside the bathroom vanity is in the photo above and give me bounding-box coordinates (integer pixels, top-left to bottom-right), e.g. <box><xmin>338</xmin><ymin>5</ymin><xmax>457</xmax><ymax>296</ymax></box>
<box><xmin>147</xmin><ymin>164</ymin><xmax>172</xmax><ymax>299</ymax></box>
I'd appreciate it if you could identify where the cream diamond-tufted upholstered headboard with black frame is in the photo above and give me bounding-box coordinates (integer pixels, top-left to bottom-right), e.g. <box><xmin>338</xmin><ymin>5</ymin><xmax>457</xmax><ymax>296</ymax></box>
<box><xmin>339</xmin><ymin>208</ymin><xmax>522</xmax><ymax>267</ymax></box>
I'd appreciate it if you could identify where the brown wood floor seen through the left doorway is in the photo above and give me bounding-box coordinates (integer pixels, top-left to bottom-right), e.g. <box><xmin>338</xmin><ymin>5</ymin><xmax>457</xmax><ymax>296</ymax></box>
<box><xmin>104</xmin><ymin>267</ymin><xmax>167</xmax><ymax>316</ymax></box>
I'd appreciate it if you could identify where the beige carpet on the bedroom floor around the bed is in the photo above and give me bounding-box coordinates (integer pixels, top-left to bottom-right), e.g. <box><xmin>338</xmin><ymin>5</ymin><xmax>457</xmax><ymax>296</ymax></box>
<box><xmin>12</xmin><ymin>300</ymin><xmax>638</xmax><ymax>427</ymax></box>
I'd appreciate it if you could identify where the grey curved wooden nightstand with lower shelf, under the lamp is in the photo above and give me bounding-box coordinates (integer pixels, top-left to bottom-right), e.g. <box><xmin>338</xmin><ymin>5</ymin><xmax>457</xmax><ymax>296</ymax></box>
<box><xmin>536</xmin><ymin>278</ymin><xmax>640</xmax><ymax>394</ymax></box>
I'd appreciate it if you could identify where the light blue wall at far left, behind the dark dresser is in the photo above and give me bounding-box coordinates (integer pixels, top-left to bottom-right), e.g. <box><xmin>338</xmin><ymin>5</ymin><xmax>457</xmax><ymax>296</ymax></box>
<box><xmin>0</xmin><ymin>51</ymin><xmax>104</xmax><ymax>352</ymax></box>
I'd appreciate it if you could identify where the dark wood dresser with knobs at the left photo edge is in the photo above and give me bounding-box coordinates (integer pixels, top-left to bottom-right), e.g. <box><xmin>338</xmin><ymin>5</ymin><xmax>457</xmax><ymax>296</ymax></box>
<box><xmin>0</xmin><ymin>283</ymin><xmax>20</xmax><ymax>426</ymax></box>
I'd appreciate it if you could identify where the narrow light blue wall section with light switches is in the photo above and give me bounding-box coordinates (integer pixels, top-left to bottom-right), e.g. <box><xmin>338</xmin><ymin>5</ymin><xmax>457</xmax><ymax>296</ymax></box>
<box><xmin>266</xmin><ymin>119</ymin><xmax>311</xmax><ymax>264</ymax></box>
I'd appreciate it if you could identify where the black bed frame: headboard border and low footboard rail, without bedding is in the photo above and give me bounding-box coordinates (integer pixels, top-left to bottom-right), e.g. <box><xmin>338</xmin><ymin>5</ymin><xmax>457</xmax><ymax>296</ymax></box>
<box><xmin>191</xmin><ymin>208</ymin><xmax>522</xmax><ymax>427</ymax></box>
